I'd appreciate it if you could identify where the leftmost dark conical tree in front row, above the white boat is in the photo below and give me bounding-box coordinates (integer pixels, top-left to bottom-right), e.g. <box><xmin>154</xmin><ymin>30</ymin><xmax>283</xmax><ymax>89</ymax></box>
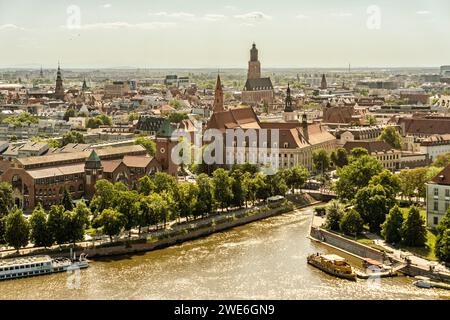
<box><xmin>4</xmin><ymin>208</ymin><xmax>30</xmax><ymax>252</ymax></box>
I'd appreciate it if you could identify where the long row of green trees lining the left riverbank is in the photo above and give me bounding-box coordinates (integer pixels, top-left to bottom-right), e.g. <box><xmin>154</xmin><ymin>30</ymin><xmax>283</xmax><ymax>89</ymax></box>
<box><xmin>0</xmin><ymin>164</ymin><xmax>309</xmax><ymax>254</ymax></box>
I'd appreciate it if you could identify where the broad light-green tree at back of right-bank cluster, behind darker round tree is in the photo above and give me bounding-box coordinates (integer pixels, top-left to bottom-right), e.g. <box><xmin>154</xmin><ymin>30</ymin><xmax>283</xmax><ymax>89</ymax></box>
<box><xmin>335</xmin><ymin>155</ymin><xmax>383</xmax><ymax>201</ymax></box>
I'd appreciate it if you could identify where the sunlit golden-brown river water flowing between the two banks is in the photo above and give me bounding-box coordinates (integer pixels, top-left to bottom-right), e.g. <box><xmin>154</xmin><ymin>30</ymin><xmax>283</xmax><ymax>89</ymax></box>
<box><xmin>0</xmin><ymin>209</ymin><xmax>450</xmax><ymax>299</ymax></box>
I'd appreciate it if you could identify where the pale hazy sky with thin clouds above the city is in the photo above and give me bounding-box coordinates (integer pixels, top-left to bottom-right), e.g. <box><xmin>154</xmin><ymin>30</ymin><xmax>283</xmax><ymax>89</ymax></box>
<box><xmin>0</xmin><ymin>0</ymin><xmax>450</xmax><ymax>68</ymax></box>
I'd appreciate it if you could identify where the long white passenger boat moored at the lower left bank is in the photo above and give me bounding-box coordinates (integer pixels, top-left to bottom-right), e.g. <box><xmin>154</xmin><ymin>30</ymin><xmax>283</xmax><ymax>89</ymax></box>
<box><xmin>0</xmin><ymin>254</ymin><xmax>89</xmax><ymax>281</ymax></box>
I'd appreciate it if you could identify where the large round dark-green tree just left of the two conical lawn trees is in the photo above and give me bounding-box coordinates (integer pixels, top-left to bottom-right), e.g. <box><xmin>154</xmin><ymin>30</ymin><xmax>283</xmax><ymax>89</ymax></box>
<box><xmin>355</xmin><ymin>185</ymin><xmax>394</xmax><ymax>233</ymax></box>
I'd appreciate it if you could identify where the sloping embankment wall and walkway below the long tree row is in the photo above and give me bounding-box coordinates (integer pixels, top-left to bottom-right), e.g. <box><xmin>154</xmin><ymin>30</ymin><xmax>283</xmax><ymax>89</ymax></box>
<box><xmin>2</xmin><ymin>197</ymin><xmax>319</xmax><ymax>259</ymax></box>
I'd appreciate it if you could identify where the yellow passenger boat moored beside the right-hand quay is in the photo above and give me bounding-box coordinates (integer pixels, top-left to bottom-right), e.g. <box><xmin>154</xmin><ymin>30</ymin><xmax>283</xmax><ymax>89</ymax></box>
<box><xmin>307</xmin><ymin>253</ymin><xmax>356</xmax><ymax>281</ymax></box>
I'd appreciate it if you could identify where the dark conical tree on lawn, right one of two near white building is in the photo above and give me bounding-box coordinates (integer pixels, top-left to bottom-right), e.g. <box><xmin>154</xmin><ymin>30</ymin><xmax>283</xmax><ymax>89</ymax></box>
<box><xmin>402</xmin><ymin>206</ymin><xmax>427</xmax><ymax>247</ymax></box>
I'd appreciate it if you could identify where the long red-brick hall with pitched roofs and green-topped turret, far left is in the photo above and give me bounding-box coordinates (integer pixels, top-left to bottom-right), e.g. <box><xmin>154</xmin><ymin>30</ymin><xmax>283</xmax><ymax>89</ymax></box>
<box><xmin>0</xmin><ymin>145</ymin><xmax>161</xmax><ymax>212</ymax></box>
